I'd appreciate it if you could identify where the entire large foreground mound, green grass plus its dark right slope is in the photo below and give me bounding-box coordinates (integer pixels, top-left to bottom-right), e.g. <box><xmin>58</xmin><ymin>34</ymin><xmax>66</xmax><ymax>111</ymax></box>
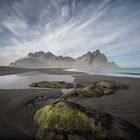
<box><xmin>34</xmin><ymin>100</ymin><xmax>140</xmax><ymax>140</ymax></box>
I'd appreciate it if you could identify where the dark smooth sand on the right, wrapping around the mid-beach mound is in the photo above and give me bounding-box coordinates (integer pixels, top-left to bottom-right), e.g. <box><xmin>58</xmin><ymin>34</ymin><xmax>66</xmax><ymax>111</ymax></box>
<box><xmin>72</xmin><ymin>75</ymin><xmax>140</xmax><ymax>128</ymax></box>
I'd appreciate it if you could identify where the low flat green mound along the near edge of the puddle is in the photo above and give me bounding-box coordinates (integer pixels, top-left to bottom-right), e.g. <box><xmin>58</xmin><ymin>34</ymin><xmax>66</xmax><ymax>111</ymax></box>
<box><xmin>29</xmin><ymin>81</ymin><xmax>73</xmax><ymax>88</ymax></box>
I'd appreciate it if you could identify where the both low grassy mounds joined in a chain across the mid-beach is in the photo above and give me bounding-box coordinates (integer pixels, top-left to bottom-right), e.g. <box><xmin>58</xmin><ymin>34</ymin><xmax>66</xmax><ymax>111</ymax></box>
<box><xmin>29</xmin><ymin>80</ymin><xmax>128</xmax><ymax>98</ymax></box>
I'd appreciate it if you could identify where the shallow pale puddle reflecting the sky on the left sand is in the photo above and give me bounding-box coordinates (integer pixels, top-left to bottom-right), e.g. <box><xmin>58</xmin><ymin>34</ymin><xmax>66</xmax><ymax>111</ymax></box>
<box><xmin>0</xmin><ymin>71</ymin><xmax>74</xmax><ymax>89</ymax></box>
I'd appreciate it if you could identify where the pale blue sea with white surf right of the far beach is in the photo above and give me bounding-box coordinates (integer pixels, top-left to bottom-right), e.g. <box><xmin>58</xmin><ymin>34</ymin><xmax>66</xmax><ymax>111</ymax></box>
<box><xmin>67</xmin><ymin>68</ymin><xmax>140</xmax><ymax>78</ymax></box>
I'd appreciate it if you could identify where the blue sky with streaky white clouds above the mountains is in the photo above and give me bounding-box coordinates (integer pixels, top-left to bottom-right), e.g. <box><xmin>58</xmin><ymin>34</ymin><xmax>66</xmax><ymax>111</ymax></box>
<box><xmin>0</xmin><ymin>0</ymin><xmax>140</xmax><ymax>67</ymax></box>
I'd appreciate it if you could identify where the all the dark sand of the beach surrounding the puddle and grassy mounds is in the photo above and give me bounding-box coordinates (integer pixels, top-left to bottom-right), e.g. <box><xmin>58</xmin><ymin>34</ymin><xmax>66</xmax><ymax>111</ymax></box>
<box><xmin>0</xmin><ymin>68</ymin><xmax>140</xmax><ymax>139</ymax></box>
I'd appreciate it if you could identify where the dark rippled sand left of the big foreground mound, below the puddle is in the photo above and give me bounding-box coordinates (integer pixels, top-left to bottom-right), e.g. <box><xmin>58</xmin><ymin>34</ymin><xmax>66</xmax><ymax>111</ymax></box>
<box><xmin>0</xmin><ymin>89</ymin><xmax>62</xmax><ymax>139</ymax></box>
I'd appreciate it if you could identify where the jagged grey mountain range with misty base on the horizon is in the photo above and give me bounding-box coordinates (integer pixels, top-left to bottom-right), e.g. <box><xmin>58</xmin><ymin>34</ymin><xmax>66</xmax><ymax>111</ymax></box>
<box><xmin>9</xmin><ymin>50</ymin><xmax>117</xmax><ymax>68</ymax></box>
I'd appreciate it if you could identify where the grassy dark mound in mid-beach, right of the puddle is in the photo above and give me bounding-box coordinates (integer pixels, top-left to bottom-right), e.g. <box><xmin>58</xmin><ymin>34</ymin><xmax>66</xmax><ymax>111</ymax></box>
<box><xmin>68</xmin><ymin>80</ymin><xmax>128</xmax><ymax>97</ymax></box>
